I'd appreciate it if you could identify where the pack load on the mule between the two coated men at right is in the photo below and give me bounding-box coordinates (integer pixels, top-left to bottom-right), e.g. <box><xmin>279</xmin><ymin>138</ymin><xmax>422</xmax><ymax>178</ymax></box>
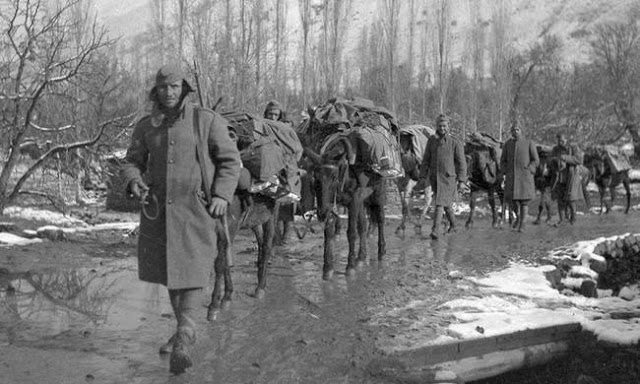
<box><xmin>464</xmin><ymin>132</ymin><xmax>502</xmax><ymax>184</ymax></box>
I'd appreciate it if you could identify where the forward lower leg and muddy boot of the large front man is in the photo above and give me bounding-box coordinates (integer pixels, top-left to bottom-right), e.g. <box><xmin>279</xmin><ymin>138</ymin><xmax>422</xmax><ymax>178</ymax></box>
<box><xmin>169</xmin><ymin>288</ymin><xmax>201</xmax><ymax>374</ymax></box>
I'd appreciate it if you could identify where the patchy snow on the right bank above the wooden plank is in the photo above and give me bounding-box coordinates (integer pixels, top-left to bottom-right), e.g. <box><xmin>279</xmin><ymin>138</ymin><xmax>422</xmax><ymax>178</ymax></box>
<box><xmin>374</xmin><ymin>235</ymin><xmax>640</xmax><ymax>350</ymax></box>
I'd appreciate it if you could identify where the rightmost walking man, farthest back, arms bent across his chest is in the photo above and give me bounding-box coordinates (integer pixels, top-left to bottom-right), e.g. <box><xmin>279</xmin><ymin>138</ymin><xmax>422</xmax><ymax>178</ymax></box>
<box><xmin>551</xmin><ymin>133</ymin><xmax>584</xmax><ymax>224</ymax></box>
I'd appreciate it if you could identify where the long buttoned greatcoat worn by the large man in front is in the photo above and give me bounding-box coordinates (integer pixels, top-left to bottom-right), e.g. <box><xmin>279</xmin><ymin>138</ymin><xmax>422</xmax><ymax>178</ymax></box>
<box><xmin>122</xmin><ymin>99</ymin><xmax>241</xmax><ymax>289</ymax></box>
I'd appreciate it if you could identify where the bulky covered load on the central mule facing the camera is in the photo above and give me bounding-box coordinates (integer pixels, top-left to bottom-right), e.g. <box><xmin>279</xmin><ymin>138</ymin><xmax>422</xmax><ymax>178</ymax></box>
<box><xmin>299</xmin><ymin>98</ymin><xmax>404</xmax><ymax>179</ymax></box>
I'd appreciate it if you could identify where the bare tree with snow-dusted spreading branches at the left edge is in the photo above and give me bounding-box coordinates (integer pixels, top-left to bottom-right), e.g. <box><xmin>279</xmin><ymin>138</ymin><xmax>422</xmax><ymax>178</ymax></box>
<box><xmin>0</xmin><ymin>0</ymin><xmax>129</xmax><ymax>212</ymax></box>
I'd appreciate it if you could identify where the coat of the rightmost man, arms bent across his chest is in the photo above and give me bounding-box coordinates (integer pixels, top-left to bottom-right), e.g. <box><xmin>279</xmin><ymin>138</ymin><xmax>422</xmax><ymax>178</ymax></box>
<box><xmin>551</xmin><ymin>144</ymin><xmax>584</xmax><ymax>202</ymax></box>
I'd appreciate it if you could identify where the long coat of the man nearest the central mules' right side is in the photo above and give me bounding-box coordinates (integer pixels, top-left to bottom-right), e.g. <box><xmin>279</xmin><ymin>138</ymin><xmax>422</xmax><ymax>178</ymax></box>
<box><xmin>420</xmin><ymin>135</ymin><xmax>467</xmax><ymax>207</ymax></box>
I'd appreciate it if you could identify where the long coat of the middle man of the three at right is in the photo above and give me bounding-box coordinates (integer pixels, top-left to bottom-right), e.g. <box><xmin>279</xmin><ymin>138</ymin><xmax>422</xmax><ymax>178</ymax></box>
<box><xmin>500</xmin><ymin>137</ymin><xmax>540</xmax><ymax>201</ymax></box>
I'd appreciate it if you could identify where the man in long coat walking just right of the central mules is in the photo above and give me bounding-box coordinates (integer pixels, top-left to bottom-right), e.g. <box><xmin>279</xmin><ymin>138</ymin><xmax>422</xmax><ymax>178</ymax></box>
<box><xmin>420</xmin><ymin>115</ymin><xmax>467</xmax><ymax>240</ymax></box>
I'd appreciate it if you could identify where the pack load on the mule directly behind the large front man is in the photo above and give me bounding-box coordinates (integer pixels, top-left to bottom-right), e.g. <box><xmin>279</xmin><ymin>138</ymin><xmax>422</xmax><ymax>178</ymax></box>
<box><xmin>222</xmin><ymin>112</ymin><xmax>302</xmax><ymax>202</ymax></box>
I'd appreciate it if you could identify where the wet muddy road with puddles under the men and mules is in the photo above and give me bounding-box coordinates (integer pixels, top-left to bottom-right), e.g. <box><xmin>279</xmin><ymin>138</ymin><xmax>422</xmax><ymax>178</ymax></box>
<box><xmin>0</xmin><ymin>202</ymin><xmax>640</xmax><ymax>384</ymax></box>
